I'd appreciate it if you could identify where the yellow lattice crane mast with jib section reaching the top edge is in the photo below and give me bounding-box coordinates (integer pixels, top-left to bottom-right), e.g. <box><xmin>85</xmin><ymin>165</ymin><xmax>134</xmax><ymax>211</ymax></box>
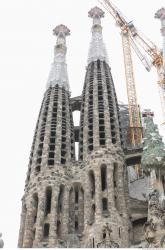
<box><xmin>99</xmin><ymin>0</ymin><xmax>142</xmax><ymax>146</ymax></box>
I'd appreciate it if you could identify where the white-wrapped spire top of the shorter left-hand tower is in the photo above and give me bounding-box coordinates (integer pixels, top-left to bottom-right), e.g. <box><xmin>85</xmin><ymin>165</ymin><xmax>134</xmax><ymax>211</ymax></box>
<box><xmin>47</xmin><ymin>24</ymin><xmax>70</xmax><ymax>90</ymax></box>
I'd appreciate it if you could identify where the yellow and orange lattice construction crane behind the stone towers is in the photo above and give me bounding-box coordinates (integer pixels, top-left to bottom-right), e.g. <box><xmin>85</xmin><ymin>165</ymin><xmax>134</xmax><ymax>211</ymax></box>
<box><xmin>98</xmin><ymin>0</ymin><xmax>165</xmax><ymax>145</ymax></box>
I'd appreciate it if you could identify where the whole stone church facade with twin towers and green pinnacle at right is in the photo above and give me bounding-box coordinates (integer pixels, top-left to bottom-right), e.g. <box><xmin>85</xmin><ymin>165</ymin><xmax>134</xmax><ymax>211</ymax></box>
<box><xmin>18</xmin><ymin>7</ymin><xmax>165</xmax><ymax>248</ymax></box>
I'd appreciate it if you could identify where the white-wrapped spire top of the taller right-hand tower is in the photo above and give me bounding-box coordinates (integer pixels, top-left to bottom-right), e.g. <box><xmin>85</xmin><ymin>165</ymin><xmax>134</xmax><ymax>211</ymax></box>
<box><xmin>88</xmin><ymin>7</ymin><xmax>108</xmax><ymax>64</ymax></box>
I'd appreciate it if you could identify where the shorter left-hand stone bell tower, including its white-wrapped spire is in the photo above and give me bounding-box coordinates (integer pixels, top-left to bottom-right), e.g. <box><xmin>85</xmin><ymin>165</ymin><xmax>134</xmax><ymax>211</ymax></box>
<box><xmin>18</xmin><ymin>25</ymin><xmax>75</xmax><ymax>248</ymax></box>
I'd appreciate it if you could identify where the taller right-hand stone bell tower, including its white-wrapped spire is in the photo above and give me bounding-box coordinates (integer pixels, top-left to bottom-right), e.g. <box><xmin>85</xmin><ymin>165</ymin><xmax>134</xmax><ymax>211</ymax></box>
<box><xmin>79</xmin><ymin>7</ymin><xmax>128</xmax><ymax>247</ymax></box>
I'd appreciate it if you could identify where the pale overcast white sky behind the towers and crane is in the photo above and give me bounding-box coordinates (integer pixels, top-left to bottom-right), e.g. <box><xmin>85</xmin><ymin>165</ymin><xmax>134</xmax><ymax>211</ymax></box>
<box><xmin>0</xmin><ymin>0</ymin><xmax>164</xmax><ymax>247</ymax></box>
